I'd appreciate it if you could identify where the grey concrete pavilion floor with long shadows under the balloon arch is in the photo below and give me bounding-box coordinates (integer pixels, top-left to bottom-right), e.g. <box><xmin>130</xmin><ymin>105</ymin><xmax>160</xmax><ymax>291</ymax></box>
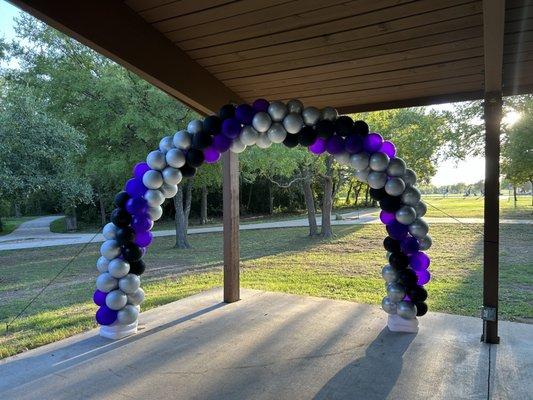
<box><xmin>0</xmin><ymin>289</ymin><xmax>533</xmax><ymax>400</ymax></box>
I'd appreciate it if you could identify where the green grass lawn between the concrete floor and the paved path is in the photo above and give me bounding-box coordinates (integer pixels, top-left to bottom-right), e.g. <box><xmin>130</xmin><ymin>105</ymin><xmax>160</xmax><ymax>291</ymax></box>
<box><xmin>0</xmin><ymin>224</ymin><xmax>533</xmax><ymax>357</ymax></box>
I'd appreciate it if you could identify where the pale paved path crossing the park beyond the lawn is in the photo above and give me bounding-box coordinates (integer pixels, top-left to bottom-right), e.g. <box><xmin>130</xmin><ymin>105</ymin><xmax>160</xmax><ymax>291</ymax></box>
<box><xmin>0</xmin><ymin>208</ymin><xmax>533</xmax><ymax>251</ymax></box>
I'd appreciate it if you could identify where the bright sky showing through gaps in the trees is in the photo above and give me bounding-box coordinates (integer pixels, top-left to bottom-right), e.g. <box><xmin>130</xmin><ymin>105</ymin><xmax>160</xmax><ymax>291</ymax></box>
<box><xmin>0</xmin><ymin>0</ymin><xmax>516</xmax><ymax>186</ymax></box>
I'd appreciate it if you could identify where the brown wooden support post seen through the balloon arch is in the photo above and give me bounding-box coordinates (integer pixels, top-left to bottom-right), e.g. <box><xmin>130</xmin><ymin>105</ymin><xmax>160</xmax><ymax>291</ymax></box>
<box><xmin>222</xmin><ymin>151</ymin><xmax>240</xmax><ymax>303</ymax></box>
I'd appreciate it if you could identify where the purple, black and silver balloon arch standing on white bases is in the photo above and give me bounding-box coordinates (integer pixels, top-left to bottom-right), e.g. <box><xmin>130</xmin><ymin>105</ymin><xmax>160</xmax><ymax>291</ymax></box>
<box><xmin>93</xmin><ymin>99</ymin><xmax>431</xmax><ymax>339</ymax></box>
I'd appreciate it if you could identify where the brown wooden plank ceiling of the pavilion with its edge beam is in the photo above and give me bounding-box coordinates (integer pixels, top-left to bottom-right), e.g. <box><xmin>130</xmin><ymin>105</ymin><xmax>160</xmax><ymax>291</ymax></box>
<box><xmin>8</xmin><ymin>0</ymin><xmax>533</xmax><ymax>111</ymax></box>
